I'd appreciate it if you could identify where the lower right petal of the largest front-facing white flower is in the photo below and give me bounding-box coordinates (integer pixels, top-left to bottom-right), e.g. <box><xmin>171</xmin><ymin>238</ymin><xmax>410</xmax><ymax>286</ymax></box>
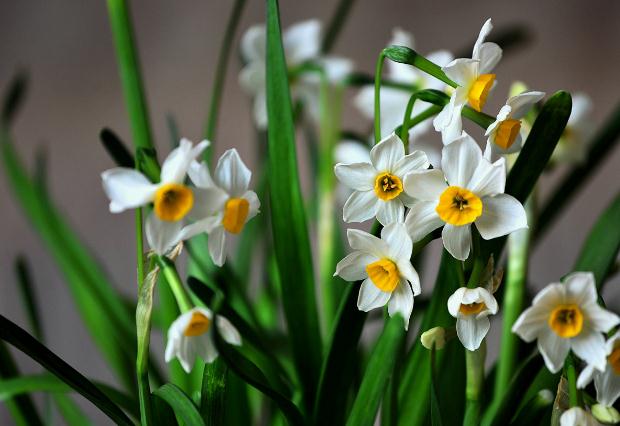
<box><xmin>475</xmin><ymin>194</ymin><xmax>527</xmax><ymax>240</ymax></box>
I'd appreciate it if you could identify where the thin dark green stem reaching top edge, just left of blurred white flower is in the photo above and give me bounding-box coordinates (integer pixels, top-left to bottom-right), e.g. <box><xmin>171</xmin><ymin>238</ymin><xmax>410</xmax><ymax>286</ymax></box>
<box><xmin>204</xmin><ymin>0</ymin><xmax>246</xmax><ymax>162</ymax></box>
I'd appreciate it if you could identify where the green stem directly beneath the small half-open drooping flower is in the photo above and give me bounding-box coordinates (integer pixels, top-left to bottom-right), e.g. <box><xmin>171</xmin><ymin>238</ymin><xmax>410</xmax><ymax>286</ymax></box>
<box><xmin>463</xmin><ymin>340</ymin><xmax>487</xmax><ymax>426</ymax></box>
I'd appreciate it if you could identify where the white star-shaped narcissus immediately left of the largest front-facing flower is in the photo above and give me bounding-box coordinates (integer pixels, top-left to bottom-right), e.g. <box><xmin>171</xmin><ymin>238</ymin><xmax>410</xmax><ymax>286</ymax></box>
<box><xmin>334</xmin><ymin>133</ymin><xmax>429</xmax><ymax>225</ymax></box>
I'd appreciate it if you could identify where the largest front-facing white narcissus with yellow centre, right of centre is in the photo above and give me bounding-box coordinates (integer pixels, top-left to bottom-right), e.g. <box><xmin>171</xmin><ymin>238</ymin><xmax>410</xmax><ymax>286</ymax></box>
<box><xmin>404</xmin><ymin>134</ymin><xmax>527</xmax><ymax>260</ymax></box>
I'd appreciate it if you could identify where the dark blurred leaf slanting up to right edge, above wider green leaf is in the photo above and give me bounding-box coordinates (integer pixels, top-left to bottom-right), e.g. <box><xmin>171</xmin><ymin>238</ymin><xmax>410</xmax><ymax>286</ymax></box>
<box><xmin>535</xmin><ymin>100</ymin><xmax>620</xmax><ymax>238</ymax></box>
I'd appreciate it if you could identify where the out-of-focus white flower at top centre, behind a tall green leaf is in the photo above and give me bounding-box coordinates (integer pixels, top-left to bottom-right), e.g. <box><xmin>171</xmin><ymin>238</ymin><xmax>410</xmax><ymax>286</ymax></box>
<box><xmin>239</xmin><ymin>19</ymin><xmax>353</xmax><ymax>129</ymax></box>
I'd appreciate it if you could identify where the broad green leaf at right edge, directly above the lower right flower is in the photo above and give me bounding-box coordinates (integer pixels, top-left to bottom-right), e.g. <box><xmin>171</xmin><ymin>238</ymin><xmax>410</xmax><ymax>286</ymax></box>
<box><xmin>573</xmin><ymin>193</ymin><xmax>620</xmax><ymax>291</ymax></box>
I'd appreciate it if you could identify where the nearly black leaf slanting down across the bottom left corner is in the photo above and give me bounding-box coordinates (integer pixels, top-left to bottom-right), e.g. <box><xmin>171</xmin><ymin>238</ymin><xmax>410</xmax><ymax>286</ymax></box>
<box><xmin>0</xmin><ymin>315</ymin><xmax>133</xmax><ymax>425</ymax></box>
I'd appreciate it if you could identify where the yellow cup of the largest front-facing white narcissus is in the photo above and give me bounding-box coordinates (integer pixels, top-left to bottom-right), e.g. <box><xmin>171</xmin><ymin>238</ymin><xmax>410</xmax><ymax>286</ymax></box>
<box><xmin>435</xmin><ymin>186</ymin><xmax>482</xmax><ymax>226</ymax></box>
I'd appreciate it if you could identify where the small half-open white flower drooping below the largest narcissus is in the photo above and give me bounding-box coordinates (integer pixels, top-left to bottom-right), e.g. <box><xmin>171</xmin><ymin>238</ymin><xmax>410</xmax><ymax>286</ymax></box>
<box><xmin>448</xmin><ymin>287</ymin><xmax>498</xmax><ymax>351</ymax></box>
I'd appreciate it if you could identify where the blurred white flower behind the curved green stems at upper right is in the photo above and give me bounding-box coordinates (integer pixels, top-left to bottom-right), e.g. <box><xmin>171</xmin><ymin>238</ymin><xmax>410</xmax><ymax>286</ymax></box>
<box><xmin>354</xmin><ymin>28</ymin><xmax>453</xmax><ymax>143</ymax></box>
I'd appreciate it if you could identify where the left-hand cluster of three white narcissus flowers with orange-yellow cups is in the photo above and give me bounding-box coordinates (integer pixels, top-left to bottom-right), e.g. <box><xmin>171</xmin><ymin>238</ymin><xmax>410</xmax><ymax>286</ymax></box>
<box><xmin>101</xmin><ymin>139</ymin><xmax>260</xmax><ymax>372</ymax></box>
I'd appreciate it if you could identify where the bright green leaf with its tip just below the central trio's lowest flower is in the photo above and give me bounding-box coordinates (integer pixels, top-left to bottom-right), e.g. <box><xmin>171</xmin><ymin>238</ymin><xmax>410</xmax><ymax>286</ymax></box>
<box><xmin>347</xmin><ymin>314</ymin><xmax>406</xmax><ymax>426</ymax></box>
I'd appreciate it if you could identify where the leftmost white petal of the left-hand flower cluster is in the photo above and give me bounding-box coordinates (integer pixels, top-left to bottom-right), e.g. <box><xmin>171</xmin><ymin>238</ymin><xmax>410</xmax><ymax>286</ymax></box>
<box><xmin>101</xmin><ymin>167</ymin><xmax>158</xmax><ymax>213</ymax></box>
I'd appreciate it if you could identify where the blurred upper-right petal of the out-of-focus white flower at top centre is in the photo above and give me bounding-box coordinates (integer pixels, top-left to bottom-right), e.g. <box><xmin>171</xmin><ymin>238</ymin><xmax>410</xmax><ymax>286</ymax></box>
<box><xmin>282</xmin><ymin>19</ymin><xmax>321</xmax><ymax>66</ymax></box>
